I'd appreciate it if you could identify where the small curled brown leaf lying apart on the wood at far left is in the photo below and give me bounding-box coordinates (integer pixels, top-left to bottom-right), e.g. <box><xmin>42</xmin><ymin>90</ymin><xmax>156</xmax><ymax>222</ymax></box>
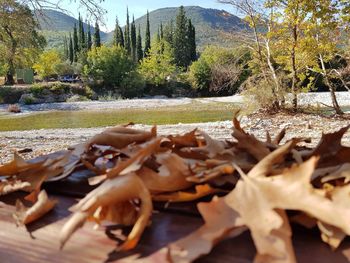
<box><xmin>14</xmin><ymin>190</ymin><xmax>57</xmax><ymax>225</ymax></box>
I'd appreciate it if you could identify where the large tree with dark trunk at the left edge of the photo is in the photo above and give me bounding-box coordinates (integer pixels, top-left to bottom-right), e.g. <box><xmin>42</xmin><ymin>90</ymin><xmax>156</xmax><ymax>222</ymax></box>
<box><xmin>0</xmin><ymin>0</ymin><xmax>46</xmax><ymax>84</ymax></box>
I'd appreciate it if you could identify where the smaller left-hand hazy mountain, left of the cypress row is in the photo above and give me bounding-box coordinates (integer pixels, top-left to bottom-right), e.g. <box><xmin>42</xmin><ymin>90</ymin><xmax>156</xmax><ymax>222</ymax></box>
<box><xmin>35</xmin><ymin>9</ymin><xmax>108</xmax><ymax>48</ymax></box>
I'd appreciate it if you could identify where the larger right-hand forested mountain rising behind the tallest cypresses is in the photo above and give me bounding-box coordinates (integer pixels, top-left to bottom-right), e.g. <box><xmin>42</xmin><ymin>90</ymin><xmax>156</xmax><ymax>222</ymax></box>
<box><xmin>108</xmin><ymin>6</ymin><xmax>248</xmax><ymax>48</ymax></box>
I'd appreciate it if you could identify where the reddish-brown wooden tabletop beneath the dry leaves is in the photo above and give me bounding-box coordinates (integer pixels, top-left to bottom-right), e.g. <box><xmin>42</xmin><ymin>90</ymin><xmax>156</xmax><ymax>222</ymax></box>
<box><xmin>0</xmin><ymin>194</ymin><xmax>350</xmax><ymax>263</ymax></box>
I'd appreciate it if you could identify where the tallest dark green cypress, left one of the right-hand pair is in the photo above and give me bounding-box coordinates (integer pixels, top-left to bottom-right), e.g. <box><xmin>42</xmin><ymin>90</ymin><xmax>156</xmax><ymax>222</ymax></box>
<box><xmin>174</xmin><ymin>6</ymin><xmax>191</xmax><ymax>69</ymax></box>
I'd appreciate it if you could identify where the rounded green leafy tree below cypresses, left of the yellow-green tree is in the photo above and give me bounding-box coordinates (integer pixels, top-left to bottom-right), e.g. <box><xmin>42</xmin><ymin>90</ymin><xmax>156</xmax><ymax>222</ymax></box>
<box><xmin>84</xmin><ymin>45</ymin><xmax>134</xmax><ymax>89</ymax></box>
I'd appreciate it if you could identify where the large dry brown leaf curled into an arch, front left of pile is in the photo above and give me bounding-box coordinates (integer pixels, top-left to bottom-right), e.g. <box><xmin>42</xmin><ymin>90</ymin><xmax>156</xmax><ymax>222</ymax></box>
<box><xmin>60</xmin><ymin>174</ymin><xmax>153</xmax><ymax>250</ymax></box>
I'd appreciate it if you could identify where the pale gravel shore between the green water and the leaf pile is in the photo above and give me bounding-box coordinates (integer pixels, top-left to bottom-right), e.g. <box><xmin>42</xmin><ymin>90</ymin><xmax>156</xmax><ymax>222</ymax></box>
<box><xmin>0</xmin><ymin>113</ymin><xmax>350</xmax><ymax>163</ymax></box>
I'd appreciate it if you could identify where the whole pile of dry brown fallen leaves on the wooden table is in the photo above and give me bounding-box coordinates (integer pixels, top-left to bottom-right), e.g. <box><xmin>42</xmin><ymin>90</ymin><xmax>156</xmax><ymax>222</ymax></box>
<box><xmin>0</xmin><ymin>118</ymin><xmax>350</xmax><ymax>262</ymax></box>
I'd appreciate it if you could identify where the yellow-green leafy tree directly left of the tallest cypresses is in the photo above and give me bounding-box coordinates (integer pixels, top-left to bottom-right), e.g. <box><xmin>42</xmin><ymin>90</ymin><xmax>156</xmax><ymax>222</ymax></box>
<box><xmin>139</xmin><ymin>40</ymin><xmax>176</xmax><ymax>86</ymax></box>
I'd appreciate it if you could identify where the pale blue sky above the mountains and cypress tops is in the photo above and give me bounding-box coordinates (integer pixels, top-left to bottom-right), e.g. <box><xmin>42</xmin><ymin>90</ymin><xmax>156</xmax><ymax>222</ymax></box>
<box><xmin>62</xmin><ymin>0</ymin><xmax>238</xmax><ymax>31</ymax></box>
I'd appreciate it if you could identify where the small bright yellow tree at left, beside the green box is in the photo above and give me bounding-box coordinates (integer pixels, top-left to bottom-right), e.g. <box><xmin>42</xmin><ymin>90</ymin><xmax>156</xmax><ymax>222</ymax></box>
<box><xmin>33</xmin><ymin>50</ymin><xmax>62</xmax><ymax>80</ymax></box>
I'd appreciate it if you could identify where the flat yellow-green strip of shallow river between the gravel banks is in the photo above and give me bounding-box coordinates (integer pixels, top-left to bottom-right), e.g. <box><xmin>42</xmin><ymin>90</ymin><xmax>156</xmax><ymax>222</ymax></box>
<box><xmin>0</xmin><ymin>103</ymin><xmax>238</xmax><ymax>131</ymax></box>
